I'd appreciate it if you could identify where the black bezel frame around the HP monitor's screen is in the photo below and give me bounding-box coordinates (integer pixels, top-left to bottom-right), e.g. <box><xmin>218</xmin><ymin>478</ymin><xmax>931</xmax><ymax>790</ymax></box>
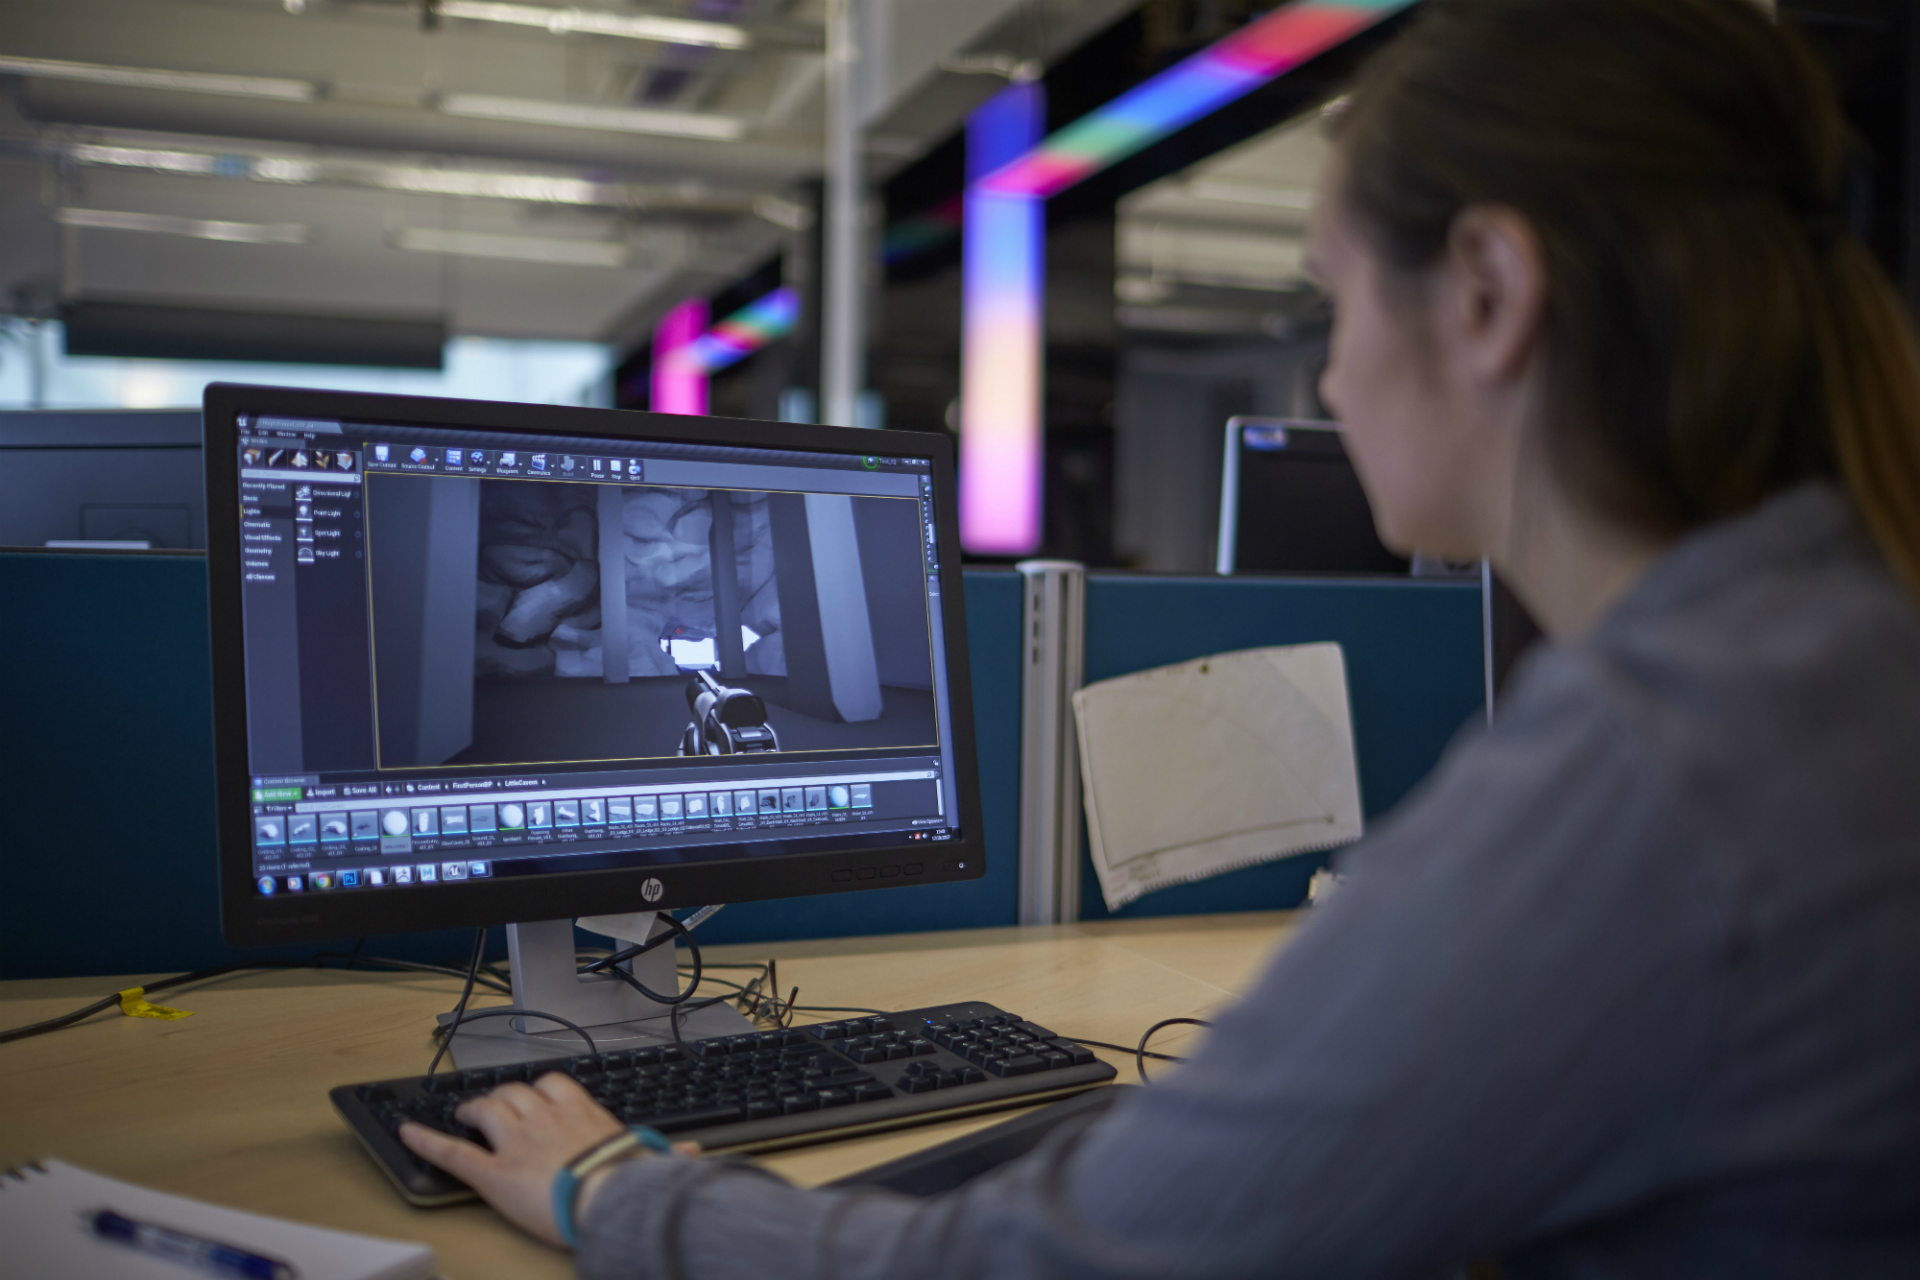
<box><xmin>202</xmin><ymin>382</ymin><xmax>987</xmax><ymax>946</ymax></box>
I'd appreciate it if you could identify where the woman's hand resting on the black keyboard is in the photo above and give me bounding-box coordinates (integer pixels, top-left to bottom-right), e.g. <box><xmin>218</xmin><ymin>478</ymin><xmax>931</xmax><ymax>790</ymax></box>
<box><xmin>399</xmin><ymin>1071</ymin><xmax>624</xmax><ymax>1245</ymax></box>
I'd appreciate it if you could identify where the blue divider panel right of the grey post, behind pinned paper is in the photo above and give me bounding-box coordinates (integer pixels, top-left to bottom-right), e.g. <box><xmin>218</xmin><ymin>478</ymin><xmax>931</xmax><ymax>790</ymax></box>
<box><xmin>1081</xmin><ymin>574</ymin><xmax>1486</xmax><ymax>919</ymax></box>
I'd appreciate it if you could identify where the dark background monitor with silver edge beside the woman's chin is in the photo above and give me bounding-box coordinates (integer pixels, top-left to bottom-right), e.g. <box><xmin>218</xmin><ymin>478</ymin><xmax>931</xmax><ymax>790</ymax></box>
<box><xmin>1215</xmin><ymin>418</ymin><xmax>1409</xmax><ymax>576</ymax></box>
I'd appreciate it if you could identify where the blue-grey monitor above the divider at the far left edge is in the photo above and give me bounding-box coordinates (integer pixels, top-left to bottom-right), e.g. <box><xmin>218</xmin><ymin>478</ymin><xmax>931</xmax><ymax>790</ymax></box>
<box><xmin>0</xmin><ymin>409</ymin><xmax>207</xmax><ymax>551</ymax></box>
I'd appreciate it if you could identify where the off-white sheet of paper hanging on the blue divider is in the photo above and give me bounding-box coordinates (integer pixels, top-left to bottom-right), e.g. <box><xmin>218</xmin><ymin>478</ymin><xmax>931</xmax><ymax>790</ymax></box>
<box><xmin>1073</xmin><ymin>645</ymin><xmax>1361</xmax><ymax>910</ymax></box>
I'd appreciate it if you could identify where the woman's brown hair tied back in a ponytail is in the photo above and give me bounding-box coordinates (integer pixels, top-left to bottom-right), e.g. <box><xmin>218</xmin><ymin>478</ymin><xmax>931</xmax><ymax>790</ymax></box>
<box><xmin>1334</xmin><ymin>0</ymin><xmax>1920</xmax><ymax>593</ymax></box>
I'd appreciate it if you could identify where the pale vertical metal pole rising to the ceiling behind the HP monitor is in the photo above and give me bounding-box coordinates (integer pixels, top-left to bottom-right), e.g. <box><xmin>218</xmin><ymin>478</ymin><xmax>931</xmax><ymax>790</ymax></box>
<box><xmin>820</xmin><ymin>0</ymin><xmax>866</xmax><ymax>426</ymax></box>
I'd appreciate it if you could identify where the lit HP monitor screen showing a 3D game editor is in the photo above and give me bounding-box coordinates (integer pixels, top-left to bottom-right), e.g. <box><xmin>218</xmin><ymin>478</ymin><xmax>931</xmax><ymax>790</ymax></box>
<box><xmin>238</xmin><ymin>415</ymin><xmax>958</xmax><ymax>894</ymax></box>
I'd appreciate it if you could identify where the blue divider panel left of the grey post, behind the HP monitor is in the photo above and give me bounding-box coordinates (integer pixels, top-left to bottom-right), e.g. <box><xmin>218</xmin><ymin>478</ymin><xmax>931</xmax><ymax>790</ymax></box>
<box><xmin>0</xmin><ymin>553</ymin><xmax>1021</xmax><ymax>979</ymax></box>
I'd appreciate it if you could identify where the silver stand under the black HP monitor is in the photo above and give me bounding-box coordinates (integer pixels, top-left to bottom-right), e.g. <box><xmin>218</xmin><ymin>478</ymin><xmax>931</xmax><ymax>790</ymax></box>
<box><xmin>440</xmin><ymin>912</ymin><xmax>755</xmax><ymax>1071</ymax></box>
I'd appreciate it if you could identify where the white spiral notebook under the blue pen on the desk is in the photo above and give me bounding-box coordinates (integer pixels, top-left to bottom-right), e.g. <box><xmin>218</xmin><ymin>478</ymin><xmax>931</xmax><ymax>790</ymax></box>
<box><xmin>0</xmin><ymin>1159</ymin><xmax>434</xmax><ymax>1280</ymax></box>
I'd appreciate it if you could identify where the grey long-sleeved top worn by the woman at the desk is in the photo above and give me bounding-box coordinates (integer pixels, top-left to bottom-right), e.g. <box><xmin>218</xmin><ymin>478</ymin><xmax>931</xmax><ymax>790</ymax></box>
<box><xmin>580</xmin><ymin>486</ymin><xmax>1920</xmax><ymax>1280</ymax></box>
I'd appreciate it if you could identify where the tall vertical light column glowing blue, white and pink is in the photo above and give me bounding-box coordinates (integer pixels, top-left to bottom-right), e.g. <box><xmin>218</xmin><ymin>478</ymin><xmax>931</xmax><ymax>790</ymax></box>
<box><xmin>960</xmin><ymin>84</ymin><xmax>1046</xmax><ymax>555</ymax></box>
